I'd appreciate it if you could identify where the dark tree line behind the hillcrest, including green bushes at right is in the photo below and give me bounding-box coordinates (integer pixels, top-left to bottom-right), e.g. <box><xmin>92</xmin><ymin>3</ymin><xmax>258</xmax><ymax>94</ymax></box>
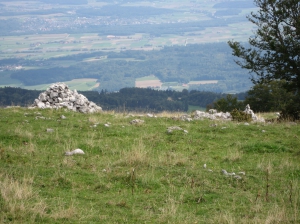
<box><xmin>0</xmin><ymin>80</ymin><xmax>293</xmax><ymax>112</ymax></box>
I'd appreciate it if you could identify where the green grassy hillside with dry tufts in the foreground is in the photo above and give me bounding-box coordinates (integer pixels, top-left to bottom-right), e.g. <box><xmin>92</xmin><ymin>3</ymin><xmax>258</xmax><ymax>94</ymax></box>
<box><xmin>0</xmin><ymin>108</ymin><xmax>300</xmax><ymax>224</ymax></box>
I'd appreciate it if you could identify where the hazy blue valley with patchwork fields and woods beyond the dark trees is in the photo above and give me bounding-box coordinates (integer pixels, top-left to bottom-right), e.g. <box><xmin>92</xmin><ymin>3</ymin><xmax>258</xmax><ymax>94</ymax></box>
<box><xmin>0</xmin><ymin>0</ymin><xmax>256</xmax><ymax>92</ymax></box>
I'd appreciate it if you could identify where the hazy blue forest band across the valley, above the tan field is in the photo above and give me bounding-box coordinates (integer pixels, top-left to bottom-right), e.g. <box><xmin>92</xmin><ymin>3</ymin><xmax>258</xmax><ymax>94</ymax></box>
<box><xmin>8</xmin><ymin>43</ymin><xmax>252</xmax><ymax>92</ymax></box>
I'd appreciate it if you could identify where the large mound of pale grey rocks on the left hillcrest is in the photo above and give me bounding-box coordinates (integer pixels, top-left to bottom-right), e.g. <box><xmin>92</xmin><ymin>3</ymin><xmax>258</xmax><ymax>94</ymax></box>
<box><xmin>32</xmin><ymin>83</ymin><xmax>102</xmax><ymax>113</ymax></box>
